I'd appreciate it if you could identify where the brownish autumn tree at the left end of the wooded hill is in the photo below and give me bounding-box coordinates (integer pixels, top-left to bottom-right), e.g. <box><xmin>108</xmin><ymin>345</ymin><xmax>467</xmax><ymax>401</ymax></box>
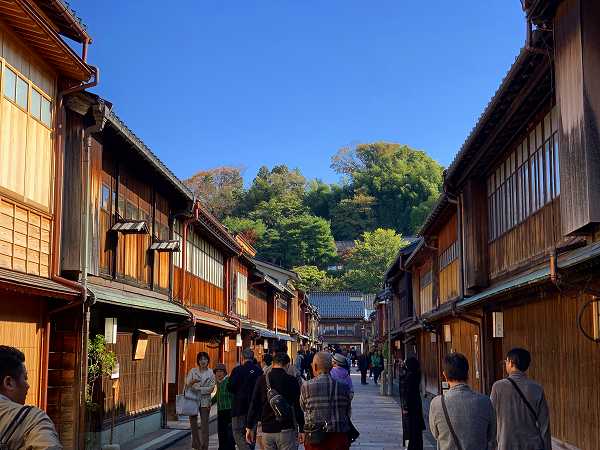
<box><xmin>184</xmin><ymin>166</ymin><xmax>244</xmax><ymax>220</ymax></box>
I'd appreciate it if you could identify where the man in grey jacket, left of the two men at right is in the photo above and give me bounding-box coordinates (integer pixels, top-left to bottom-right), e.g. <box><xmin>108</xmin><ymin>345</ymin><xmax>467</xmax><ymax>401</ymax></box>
<box><xmin>429</xmin><ymin>353</ymin><xmax>496</xmax><ymax>450</ymax></box>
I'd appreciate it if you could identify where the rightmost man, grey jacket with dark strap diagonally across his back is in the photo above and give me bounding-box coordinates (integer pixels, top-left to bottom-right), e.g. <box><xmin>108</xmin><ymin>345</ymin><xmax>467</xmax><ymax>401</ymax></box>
<box><xmin>491</xmin><ymin>348</ymin><xmax>552</xmax><ymax>450</ymax></box>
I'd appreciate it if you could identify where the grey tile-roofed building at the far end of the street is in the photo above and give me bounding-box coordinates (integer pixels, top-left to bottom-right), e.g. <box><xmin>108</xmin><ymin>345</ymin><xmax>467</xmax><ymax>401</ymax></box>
<box><xmin>309</xmin><ymin>292</ymin><xmax>374</xmax><ymax>352</ymax></box>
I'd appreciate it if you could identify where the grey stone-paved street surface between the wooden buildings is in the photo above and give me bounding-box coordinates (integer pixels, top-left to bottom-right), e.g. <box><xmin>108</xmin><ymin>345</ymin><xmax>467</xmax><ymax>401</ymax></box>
<box><xmin>164</xmin><ymin>373</ymin><xmax>436</xmax><ymax>450</ymax></box>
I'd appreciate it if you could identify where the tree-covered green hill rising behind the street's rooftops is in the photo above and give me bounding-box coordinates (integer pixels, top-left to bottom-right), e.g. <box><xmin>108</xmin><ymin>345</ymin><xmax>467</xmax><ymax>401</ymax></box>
<box><xmin>186</xmin><ymin>142</ymin><xmax>442</xmax><ymax>292</ymax></box>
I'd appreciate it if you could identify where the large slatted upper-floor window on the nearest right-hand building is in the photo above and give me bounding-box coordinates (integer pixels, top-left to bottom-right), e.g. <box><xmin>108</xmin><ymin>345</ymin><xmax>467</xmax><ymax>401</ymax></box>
<box><xmin>487</xmin><ymin>107</ymin><xmax>560</xmax><ymax>241</ymax></box>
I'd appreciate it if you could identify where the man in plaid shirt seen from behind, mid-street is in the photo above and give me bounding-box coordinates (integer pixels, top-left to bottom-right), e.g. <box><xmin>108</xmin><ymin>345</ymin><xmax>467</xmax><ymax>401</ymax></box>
<box><xmin>300</xmin><ymin>352</ymin><xmax>351</xmax><ymax>450</ymax></box>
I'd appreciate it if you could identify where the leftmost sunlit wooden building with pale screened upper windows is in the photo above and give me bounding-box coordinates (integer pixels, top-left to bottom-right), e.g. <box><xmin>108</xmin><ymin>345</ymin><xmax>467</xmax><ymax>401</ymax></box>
<box><xmin>0</xmin><ymin>0</ymin><xmax>97</xmax><ymax>448</ymax></box>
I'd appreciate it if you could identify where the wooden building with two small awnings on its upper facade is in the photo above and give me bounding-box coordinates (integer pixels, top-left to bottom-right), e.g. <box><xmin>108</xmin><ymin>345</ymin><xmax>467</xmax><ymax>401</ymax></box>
<box><xmin>59</xmin><ymin>93</ymin><xmax>194</xmax><ymax>448</ymax></box>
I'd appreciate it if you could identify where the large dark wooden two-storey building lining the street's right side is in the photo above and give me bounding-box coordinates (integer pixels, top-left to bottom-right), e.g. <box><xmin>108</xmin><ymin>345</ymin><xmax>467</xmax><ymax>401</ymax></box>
<box><xmin>392</xmin><ymin>0</ymin><xmax>600</xmax><ymax>450</ymax></box>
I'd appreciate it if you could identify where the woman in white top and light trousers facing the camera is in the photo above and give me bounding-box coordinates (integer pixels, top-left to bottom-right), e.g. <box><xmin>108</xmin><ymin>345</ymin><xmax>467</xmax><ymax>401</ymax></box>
<box><xmin>185</xmin><ymin>352</ymin><xmax>216</xmax><ymax>450</ymax></box>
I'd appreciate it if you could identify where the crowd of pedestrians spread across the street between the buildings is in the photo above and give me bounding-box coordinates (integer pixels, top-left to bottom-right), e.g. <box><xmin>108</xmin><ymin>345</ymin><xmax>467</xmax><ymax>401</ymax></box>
<box><xmin>0</xmin><ymin>341</ymin><xmax>552</xmax><ymax>450</ymax></box>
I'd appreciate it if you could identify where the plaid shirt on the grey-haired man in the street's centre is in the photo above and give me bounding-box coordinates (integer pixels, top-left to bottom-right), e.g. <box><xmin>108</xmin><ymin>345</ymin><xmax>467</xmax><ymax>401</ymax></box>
<box><xmin>300</xmin><ymin>374</ymin><xmax>350</xmax><ymax>433</ymax></box>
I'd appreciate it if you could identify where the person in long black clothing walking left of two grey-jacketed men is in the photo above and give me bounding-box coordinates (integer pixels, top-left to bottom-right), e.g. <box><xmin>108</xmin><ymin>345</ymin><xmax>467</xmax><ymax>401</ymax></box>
<box><xmin>400</xmin><ymin>356</ymin><xmax>425</xmax><ymax>450</ymax></box>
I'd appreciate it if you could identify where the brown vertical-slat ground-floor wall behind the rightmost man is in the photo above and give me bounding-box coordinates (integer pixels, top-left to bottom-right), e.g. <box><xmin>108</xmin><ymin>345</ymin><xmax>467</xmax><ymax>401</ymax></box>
<box><xmin>502</xmin><ymin>293</ymin><xmax>600</xmax><ymax>450</ymax></box>
